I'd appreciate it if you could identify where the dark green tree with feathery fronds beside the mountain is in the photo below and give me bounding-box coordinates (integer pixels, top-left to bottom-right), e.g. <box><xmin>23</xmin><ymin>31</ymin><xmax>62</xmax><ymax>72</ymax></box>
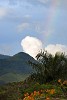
<box><xmin>29</xmin><ymin>51</ymin><xmax>67</xmax><ymax>83</ymax></box>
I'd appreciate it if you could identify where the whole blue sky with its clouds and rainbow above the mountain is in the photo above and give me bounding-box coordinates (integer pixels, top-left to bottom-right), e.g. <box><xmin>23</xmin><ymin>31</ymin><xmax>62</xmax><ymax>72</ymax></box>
<box><xmin>0</xmin><ymin>0</ymin><xmax>67</xmax><ymax>58</ymax></box>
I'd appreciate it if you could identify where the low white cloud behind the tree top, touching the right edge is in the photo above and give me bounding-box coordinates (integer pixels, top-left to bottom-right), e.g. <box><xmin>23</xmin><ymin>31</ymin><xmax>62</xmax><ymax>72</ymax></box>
<box><xmin>45</xmin><ymin>44</ymin><xmax>67</xmax><ymax>55</ymax></box>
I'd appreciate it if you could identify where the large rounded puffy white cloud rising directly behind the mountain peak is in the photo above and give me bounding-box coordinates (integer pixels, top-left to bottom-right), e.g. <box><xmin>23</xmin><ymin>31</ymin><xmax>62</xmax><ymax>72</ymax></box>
<box><xmin>21</xmin><ymin>36</ymin><xmax>43</xmax><ymax>58</ymax></box>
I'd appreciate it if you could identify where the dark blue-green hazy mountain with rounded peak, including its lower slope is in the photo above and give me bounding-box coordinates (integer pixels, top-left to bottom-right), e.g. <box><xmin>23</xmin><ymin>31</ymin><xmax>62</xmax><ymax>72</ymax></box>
<box><xmin>0</xmin><ymin>52</ymin><xmax>35</xmax><ymax>83</ymax></box>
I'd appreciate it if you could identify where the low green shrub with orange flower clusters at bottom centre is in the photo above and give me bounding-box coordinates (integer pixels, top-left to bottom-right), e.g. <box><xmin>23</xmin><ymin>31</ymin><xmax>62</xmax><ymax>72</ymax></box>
<box><xmin>23</xmin><ymin>83</ymin><xmax>63</xmax><ymax>100</ymax></box>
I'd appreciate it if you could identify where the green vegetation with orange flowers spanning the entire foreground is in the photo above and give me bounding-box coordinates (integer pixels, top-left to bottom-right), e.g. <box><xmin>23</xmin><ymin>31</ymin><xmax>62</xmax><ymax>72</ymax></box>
<box><xmin>0</xmin><ymin>80</ymin><xmax>67</xmax><ymax>100</ymax></box>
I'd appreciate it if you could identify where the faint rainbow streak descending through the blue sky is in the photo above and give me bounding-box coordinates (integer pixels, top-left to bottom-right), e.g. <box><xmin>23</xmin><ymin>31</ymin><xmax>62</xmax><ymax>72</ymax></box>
<box><xmin>45</xmin><ymin>0</ymin><xmax>62</xmax><ymax>37</ymax></box>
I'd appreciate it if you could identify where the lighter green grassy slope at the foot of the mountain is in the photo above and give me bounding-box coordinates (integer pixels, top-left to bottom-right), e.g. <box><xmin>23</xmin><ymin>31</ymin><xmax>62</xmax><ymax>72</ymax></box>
<box><xmin>0</xmin><ymin>73</ymin><xmax>29</xmax><ymax>83</ymax></box>
